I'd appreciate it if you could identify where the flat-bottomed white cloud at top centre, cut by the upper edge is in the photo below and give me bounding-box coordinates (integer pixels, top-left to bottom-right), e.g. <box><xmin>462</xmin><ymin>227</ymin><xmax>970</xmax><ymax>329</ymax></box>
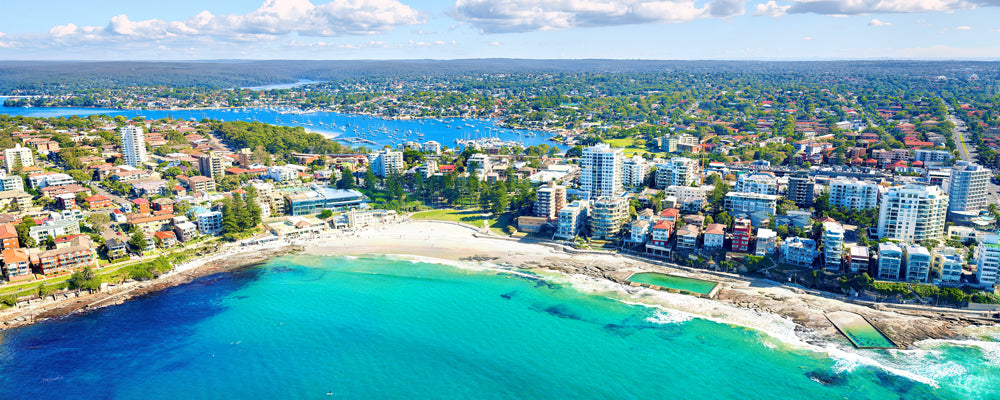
<box><xmin>448</xmin><ymin>0</ymin><xmax>746</xmax><ymax>33</ymax></box>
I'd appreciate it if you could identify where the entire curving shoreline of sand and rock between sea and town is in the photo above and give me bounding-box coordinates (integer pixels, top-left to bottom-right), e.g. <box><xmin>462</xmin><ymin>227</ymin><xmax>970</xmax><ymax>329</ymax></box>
<box><xmin>0</xmin><ymin>220</ymin><xmax>985</xmax><ymax>349</ymax></box>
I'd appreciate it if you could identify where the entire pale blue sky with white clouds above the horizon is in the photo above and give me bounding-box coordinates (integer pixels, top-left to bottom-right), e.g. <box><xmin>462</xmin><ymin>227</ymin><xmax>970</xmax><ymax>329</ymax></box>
<box><xmin>0</xmin><ymin>0</ymin><xmax>1000</xmax><ymax>60</ymax></box>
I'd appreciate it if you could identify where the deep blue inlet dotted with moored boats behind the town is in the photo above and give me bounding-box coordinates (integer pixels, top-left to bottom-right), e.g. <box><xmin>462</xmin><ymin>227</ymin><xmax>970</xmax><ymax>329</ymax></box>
<box><xmin>0</xmin><ymin>97</ymin><xmax>566</xmax><ymax>150</ymax></box>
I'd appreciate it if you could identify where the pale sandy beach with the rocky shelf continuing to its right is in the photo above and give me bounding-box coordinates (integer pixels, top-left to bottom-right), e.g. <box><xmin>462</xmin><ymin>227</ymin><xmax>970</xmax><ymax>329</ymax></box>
<box><xmin>298</xmin><ymin>221</ymin><xmax>983</xmax><ymax>347</ymax></box>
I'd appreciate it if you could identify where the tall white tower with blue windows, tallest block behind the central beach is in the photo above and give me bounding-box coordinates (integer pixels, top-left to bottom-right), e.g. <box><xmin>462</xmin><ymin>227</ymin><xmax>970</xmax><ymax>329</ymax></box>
<box><xmin>580</xmin><ymin>143</ymin><xmax>624</xmax><ymax>199</ymax></box>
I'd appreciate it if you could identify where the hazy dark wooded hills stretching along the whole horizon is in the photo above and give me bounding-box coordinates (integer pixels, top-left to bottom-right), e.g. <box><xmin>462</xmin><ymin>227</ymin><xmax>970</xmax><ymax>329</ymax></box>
<box><xmin>0</xmin><ymin>59</ymin><xmax>1000</xmax><ymax>94</ymax></box>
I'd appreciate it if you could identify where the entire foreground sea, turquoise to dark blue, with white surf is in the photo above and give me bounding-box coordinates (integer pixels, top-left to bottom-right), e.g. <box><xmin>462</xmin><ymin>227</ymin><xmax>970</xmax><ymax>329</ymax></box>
<box><xmin>0</xmin><ymin>256</ymin><xmax>1000</xmax><ymax>400</ymax></box>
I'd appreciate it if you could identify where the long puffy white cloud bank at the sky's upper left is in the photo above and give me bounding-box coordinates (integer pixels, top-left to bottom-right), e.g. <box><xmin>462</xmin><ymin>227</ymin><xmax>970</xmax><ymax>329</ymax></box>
<box><xmin>0</xmin><ymin>0</ymin><xmax>426</xmax><ymax>47</ymax></box>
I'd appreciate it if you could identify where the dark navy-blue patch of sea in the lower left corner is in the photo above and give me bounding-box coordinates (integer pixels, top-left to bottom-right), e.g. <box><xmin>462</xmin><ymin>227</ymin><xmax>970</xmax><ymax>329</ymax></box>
<box><xmin>0</xmin><ymin>269</ymin><xmax>262</xmax><ymax>400</ymax></box>
